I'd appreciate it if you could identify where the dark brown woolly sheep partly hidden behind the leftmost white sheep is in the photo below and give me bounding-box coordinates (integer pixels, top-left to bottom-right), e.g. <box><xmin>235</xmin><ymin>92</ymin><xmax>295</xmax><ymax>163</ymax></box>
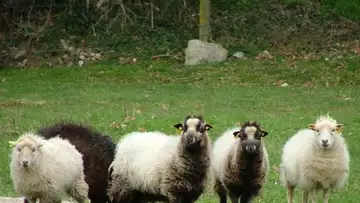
<box><xmin>25</xmin><ymin>122</ymin><xmax>116</xmax><ymax>203</ymax></box>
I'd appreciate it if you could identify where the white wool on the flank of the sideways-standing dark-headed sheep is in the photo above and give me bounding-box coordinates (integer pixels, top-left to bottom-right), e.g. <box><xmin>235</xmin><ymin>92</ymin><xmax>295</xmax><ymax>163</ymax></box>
<box><xmin>110</xmin><ymin>132</ymin><xmax>180</xmax><ymax>193</ymax></box>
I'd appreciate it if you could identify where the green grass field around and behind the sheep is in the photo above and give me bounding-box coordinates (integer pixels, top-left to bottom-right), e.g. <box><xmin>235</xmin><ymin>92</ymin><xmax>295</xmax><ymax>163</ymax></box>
<box><xmin>0</xmin><ymin>59</ymin><xmax>360</xmax><ymax>203</ymax></box>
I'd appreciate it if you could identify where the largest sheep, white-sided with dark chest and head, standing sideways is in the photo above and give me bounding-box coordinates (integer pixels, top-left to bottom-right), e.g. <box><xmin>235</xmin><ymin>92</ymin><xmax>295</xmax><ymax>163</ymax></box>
<box><xmin>108</xmin><ymin>116</ymin><xmax>213</xmax><ymax>203</ymax></box>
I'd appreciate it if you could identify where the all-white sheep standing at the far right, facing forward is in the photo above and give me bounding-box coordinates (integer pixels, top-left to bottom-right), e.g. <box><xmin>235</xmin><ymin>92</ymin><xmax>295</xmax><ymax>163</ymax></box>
<box><xmin>279</xmin><ymin>114</ymin><xmax>350</xmax><ymax>203</ymax></box>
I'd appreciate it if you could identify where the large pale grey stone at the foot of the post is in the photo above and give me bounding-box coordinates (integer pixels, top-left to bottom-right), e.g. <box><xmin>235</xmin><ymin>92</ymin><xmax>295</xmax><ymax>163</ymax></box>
<box><xmin>185</xmin><ymin>39</ymin><xmax>228</xmax><ymax>65</ymax></box>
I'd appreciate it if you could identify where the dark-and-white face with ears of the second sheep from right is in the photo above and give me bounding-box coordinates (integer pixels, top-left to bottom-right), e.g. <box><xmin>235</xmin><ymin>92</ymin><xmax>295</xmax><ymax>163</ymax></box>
<box><xmin>233</xmin><ymin>122</ymin><xmax>268</xmax><ymax>154</ymax></box>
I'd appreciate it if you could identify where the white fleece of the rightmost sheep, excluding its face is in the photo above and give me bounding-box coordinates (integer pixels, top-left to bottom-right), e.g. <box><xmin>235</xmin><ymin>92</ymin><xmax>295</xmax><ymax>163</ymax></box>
<box><xmin>280</xmin><ymin>117</ymin><xmax>350</xmax><ymax>190</ymax></box>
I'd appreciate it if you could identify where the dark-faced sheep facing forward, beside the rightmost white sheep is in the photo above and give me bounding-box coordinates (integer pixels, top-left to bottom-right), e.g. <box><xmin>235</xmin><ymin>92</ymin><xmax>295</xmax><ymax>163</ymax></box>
<box><xmin>211</xmin><ymin>121</ymin><xmax>269</xmax><ymax>203</ymax></box>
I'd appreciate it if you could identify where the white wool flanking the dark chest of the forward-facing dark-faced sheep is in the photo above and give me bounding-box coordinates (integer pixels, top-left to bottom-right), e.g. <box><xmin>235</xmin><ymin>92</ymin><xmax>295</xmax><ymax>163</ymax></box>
<box><xmin>211</xmin><ymin>128</ymin><xmax>269</xmax><ymax>184</ymax></box>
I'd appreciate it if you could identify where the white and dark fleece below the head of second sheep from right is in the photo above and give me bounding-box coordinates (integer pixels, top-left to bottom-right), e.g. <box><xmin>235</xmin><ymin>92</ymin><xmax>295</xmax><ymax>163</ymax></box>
<box><xmin>211</xmin><ymin>128</ymin><xmax>269</xmax><ymax>202</ymax></box>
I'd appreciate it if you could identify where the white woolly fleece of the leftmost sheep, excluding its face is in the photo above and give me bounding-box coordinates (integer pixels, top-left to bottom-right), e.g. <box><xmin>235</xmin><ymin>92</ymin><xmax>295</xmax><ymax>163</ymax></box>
<box><xmin>10</xmin><ymin>133</ymin><xmax>88</xmax><ymax>199</ymax></box>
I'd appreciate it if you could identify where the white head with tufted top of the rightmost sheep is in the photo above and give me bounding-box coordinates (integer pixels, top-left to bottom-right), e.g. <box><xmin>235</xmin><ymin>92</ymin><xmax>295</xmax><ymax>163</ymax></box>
<box><xmin>308</xmin><ymin>115</ymin><xmax>344</xmax><ymax>149</ymax></box>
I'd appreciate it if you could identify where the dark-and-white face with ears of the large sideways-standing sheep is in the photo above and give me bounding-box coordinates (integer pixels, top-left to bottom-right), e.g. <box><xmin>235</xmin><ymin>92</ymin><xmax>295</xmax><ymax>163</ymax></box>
<box><xmin>174</xmin><ymin>116</ymin><xmax>213</xmax><ymax>148</ymax></box>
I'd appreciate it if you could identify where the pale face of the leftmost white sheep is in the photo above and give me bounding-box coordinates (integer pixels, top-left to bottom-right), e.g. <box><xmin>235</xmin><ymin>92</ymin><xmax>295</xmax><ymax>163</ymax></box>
<box><xmin>13</xmin><ymin>138</ymin><xmax>43</xmax><ymax>169</ymax></box>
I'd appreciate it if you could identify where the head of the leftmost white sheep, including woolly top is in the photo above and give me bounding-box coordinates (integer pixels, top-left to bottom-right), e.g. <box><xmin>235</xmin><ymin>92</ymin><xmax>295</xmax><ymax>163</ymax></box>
<box><xmin>12</xmin><ymin>133</ymin><xmax>45</xmax><ymax>169</ymax></box>
